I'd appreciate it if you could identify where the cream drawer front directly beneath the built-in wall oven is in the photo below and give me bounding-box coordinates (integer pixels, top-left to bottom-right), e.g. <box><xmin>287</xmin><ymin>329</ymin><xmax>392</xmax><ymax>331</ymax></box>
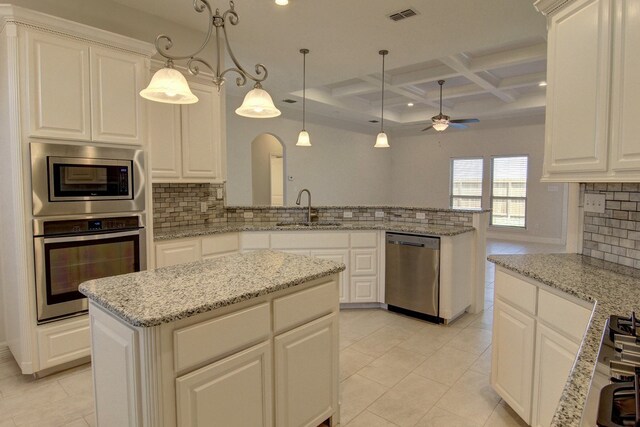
<box><xmin>37</xmin><ymin>316</ymin><xmax>91</xmax><ymax>370</ymax></box>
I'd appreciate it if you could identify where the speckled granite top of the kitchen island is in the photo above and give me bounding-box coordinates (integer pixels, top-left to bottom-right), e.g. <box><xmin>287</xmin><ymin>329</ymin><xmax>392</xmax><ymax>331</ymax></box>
<box><xmin>79</xmin><ymin>250</ymin><xmax>345</xmax><ymax>327</ymax></box>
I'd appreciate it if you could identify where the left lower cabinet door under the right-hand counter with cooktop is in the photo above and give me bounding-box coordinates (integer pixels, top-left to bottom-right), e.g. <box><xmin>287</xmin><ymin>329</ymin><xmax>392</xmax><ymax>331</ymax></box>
<box><xmin>491</xmin><ymin>299</ymin><xmax>535</xmax><ymax>424</ymax></box>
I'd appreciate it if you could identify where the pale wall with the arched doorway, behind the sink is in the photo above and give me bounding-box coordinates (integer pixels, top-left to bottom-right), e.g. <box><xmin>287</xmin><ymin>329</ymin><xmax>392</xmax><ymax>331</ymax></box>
<box><xmin>227</xmin><ymin>96</ymin><xmax>391</xmax><ymax>206</ymax></box>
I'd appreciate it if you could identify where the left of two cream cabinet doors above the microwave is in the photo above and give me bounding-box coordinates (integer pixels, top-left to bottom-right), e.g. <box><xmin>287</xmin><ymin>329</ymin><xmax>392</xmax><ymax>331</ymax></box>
<box><xmin>23</xmin><ymin>31</ymin><xmax>91</xmax><ymax>141</ymax></box>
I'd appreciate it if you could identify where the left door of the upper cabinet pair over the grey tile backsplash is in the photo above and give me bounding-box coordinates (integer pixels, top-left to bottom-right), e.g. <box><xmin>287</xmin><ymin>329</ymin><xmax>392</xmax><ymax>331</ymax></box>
<box><xmin>149</xmin><ymin>100</ymin><xmax>182</xmax><ymax>178</ymax></box>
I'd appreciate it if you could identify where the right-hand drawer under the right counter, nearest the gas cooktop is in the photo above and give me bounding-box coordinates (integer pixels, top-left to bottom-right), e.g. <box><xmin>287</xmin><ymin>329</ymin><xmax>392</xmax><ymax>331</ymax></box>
<box><xmin>538</xmin><ymin>289</ymin><xmax>591</xmax><ymax>342</ymax></box>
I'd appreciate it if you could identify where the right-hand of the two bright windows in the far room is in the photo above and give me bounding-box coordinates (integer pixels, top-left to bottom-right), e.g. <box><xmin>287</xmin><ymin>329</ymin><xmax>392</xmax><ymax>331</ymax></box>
<box><xmin>491</xmin><ymin>156</ymin><xmax>529</xmax><ymax>228</ymax></box>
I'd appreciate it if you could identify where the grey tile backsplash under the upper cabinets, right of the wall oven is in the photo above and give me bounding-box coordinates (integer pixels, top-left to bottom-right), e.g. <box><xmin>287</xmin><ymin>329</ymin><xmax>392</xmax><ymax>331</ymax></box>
<box><xmin>153</xmin><ymin>183</ymin><xmax>227</xmax><ymax>228</ymax></box>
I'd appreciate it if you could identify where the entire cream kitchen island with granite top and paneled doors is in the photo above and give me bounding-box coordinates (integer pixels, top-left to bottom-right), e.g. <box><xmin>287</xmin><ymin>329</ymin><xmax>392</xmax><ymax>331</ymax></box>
<box><xmin>80</xmin><ymin>251</ymin><xmax>345</xmax><ymax>427</ymax></box>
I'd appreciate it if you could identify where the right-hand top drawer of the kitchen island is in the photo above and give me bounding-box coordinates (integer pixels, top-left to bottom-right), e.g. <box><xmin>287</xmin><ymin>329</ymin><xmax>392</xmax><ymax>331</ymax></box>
<box><xmin>273</xmin><ymin>276</ymin><xmax>338</xmax><ymax>334</ymax></box>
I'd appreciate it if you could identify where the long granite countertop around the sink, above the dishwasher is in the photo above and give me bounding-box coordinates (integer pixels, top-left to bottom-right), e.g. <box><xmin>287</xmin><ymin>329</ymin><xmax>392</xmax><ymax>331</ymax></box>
<box><xmin>153</xmin><ymin>221</ymin><xmax>475</xmax><ymax>242</ymax></box>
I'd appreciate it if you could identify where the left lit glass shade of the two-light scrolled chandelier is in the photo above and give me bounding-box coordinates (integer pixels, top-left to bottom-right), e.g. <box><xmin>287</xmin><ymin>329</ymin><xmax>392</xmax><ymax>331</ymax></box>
<box><xmin>140</xmin><ymin>68</ymin><xmax>198</xmax><ymax>104</ymax></box>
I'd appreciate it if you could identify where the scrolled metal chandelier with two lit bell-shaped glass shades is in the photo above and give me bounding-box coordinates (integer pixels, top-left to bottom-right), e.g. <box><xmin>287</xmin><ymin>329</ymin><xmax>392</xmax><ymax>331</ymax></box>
<box><xmin>140</xmin><ymin>0</ymin><xmax>280</xmax><ymax>118</ymax></box>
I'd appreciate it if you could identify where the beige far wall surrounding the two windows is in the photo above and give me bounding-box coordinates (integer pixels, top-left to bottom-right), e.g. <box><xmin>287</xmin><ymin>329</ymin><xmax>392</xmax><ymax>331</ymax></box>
<box><xmin>390</xmin><ymin>124</ymin><xmax>566</xmax><ymax>242</ymax></box>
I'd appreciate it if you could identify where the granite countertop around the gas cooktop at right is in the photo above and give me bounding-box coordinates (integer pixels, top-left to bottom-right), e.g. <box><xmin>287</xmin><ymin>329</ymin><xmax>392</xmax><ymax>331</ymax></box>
<box><xmin>488</xmin><ymin>254</ymin><xmax>640</xmax><ymax>427</ymax></box>
